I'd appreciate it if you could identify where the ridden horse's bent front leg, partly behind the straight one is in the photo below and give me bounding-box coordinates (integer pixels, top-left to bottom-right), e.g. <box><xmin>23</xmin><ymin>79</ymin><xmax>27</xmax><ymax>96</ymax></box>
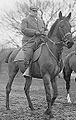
<box><xmin>51</xmin><ymin>78</ymin><xmax>58</xmax><ymax>105</ymax></box>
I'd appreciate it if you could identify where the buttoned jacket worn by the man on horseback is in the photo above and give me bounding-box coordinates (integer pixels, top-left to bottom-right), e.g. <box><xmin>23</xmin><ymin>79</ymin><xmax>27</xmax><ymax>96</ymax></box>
<box><xmin>21</xmin><ymin>15</ymin><xmax>44</xmax><ymax>44</ymax></box>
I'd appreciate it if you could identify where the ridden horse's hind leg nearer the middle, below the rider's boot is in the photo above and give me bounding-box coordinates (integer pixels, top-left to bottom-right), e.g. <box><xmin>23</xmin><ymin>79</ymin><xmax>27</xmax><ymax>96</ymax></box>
<box><xmin>24</xmin><ymin>77</ymin><xmax>34</xmax><ymax>110</ymax></box>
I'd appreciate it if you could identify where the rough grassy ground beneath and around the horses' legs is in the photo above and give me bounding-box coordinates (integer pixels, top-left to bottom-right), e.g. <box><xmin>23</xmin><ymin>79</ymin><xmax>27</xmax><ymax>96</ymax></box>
<box><xmin>0</xmin><ymin>63</ymin><xmax>76</xmax><ymax>120</ymax></box>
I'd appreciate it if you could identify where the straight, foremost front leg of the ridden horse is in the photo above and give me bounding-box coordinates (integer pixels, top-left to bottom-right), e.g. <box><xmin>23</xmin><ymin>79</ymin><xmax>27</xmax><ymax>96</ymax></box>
<box><xmin>43</xmin><ymin>73</ymin><xmax>53</xmax><ymax>118</ymax></box>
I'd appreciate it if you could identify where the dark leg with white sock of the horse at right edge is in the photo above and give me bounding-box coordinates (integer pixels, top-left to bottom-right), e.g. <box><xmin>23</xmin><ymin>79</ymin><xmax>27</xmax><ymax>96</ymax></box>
<box><xmin>63</xmin><ymin>67</ymin><xmax>72</xmax><ymax>103</ymax></box>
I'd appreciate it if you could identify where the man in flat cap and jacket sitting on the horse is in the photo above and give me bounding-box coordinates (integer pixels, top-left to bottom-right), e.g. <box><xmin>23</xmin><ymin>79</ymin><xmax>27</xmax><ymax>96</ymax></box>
<box><xmin>21</xmin><ymin>6</ymin><xmax>45</xmax><ymax>77</ymax></box>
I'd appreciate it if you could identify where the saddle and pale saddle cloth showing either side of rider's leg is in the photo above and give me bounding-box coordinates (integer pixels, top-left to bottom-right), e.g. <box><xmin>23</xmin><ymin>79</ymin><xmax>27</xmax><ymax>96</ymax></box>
<box><xmin>14</xmin><ymin>43</ymin><xmax>44</xmax><ymax>62</ymax></box>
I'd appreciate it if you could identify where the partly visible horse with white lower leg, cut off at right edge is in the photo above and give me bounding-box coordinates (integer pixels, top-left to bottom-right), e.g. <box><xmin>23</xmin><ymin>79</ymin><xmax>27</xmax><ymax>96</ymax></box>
<box><xmin>63</xmin><ymin>51</ymin><xmax>76</xmax><ymax>103</ymax></box>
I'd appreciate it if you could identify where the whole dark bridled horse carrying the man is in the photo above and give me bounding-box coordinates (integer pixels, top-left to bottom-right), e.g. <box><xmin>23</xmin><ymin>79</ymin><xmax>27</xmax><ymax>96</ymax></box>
<box><xmin>6</xmin><ymin>11</ymin><xmax>74</xmax><ymax>117</ymax></box>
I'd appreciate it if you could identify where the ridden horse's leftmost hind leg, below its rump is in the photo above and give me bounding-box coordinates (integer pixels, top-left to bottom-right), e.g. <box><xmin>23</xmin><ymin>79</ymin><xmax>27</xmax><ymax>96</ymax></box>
<box><xmin>6</xmin><ymin>63</ymin><xmax>19</xmax><ymax>110</ymax></box>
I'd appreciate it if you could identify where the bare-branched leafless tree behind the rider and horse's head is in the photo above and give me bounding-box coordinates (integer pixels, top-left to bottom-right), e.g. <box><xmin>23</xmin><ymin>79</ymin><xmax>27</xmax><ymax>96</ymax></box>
<box><xmin>0</xmin><ymin>0</ymin><xmax>76</xmax><ymax>47</ymax></box>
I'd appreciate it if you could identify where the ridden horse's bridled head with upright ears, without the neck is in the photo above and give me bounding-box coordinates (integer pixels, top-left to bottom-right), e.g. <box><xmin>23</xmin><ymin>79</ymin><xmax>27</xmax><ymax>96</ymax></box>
<box><xmin>58</xmin><ymin>11</ymin><xmax>74</xmax><ymax>48</ymax></box>
